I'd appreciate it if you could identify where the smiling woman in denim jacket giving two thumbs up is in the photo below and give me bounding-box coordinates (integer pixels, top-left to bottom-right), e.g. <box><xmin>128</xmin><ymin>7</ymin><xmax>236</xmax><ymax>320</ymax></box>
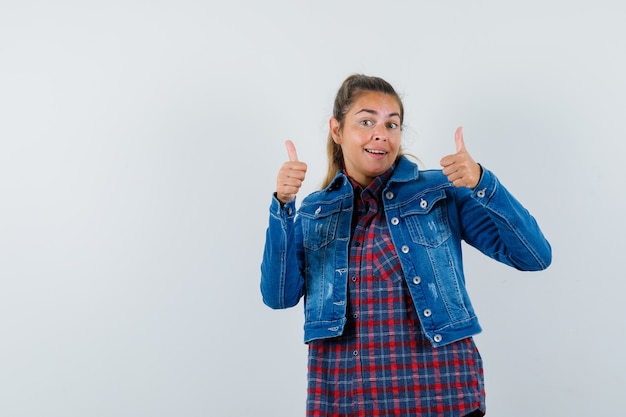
<box><xmin>261</xmin><ymin>74</ymin><xmax>551</xmax><ymax>417</ymax></box>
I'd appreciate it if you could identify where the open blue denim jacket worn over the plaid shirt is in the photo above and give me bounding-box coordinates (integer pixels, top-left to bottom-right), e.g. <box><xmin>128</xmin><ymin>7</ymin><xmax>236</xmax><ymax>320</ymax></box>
<box><xmin>261</xmin><ymin>157</ymin><xmax>552</xmax><ymax>346</ymax></box>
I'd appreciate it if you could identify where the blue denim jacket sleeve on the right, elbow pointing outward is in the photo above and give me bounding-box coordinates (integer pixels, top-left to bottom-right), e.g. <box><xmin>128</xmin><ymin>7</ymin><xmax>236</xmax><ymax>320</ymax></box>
<box><xmin>457</xmin><ymin>167</ymin><xmax>552</xmax><ymax>271</ymax></box>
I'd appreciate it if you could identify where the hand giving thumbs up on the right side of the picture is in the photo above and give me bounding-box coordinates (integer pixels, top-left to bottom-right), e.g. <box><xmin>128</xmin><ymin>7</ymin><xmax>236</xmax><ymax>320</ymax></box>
<box><xmin>440</xmin><ymin>127</ymin><xmax>482</xmax><ymax>188</ymax></box>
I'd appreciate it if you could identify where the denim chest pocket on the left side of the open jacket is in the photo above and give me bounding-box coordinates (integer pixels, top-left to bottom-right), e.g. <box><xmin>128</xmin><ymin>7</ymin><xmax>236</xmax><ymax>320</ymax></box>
<box><xmin>300</xmin><ymin>201</ymin><xmax>341</xmax><ymax>251</ymax></box>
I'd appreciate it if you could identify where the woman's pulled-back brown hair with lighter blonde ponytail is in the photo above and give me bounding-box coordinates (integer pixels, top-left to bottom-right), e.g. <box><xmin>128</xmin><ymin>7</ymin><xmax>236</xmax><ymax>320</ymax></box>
<box><xmin>322</xmin><ymin>74</ymin><xmax>404</xmax><ymax>189</ymax></box>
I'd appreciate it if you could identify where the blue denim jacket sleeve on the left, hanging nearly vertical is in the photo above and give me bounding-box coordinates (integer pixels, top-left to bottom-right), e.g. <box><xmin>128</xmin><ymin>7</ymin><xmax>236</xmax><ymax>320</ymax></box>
<box><xmin>261</xmin><ymin>193</ymin><xmax>304</xmax><ymax>309</ymax></box>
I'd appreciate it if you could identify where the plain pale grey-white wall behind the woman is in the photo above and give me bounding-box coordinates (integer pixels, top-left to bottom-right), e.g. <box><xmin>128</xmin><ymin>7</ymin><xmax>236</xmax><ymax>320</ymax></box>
<box><xmin>0</xmin><ymin>0</ymin><xmax>626</xmax><ymax>417</ymax></box>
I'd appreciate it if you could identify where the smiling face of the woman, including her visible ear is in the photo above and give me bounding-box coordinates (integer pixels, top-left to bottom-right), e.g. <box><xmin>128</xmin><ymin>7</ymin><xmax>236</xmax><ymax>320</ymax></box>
<box><xmin>330</xmin><ymin>91</ymin><xmax>401</xmax><ymax>187</ymax></box>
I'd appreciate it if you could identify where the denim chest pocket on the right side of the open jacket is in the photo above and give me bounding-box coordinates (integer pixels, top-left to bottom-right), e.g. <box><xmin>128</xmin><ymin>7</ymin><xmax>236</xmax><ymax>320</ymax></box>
<box><xmin>400</xmin><ymin>190</ymin><xmax>451</xmax><ymax>247</ymax></box>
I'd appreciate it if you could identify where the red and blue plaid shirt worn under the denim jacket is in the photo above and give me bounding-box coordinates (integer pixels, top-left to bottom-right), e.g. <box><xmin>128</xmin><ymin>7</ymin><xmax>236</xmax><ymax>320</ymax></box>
<box><xmin>307</xmin><ymin>168</ymin><xmax>485</xmax><ymax>417</ymax></box>
